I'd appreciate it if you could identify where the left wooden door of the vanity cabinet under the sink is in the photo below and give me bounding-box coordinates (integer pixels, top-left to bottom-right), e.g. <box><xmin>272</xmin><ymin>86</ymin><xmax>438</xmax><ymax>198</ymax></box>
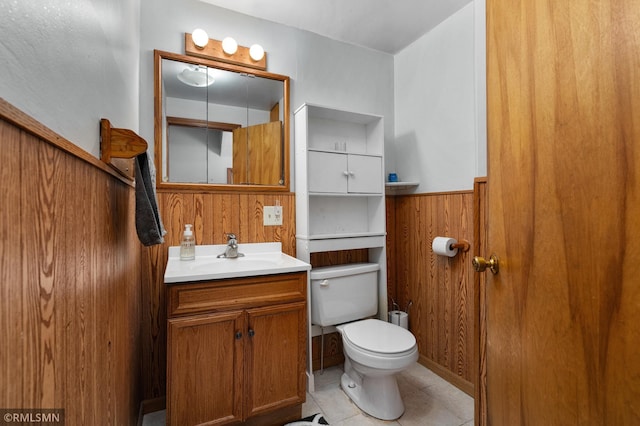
<box><xmin>167</xmin><ymin>311</ymin><xmax>246</xmax><ymax>426</ymax></box>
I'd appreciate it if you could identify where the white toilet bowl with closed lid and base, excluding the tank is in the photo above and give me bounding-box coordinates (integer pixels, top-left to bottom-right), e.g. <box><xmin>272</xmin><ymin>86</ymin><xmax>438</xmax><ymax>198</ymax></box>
<box><xmin>336</xmin><ymin>319</ymin><xmax>418</xmax><ymax>420</ymax></box>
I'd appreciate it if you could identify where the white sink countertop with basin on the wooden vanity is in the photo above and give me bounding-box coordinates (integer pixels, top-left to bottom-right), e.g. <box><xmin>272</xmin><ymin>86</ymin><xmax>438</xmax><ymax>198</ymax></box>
<box><xmin>164</xmin><ymin>243</ymin><xmax>311</xmax><ymax>283</ymax></box>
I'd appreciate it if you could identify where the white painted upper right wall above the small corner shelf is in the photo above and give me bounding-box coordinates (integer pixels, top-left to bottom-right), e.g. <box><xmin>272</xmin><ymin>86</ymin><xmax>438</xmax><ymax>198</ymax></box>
<box><xmin>394</xmin><ymin>0</ymin><xmax>486</xmax><ymax>193</ymax></box>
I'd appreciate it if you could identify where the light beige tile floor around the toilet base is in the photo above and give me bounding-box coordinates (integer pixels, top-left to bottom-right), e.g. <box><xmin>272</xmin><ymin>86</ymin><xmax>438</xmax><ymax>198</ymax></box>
<box><xmin>142</xmin><ymin>363</ymin><xmax>473</xmax><ymax>426</ymax></box>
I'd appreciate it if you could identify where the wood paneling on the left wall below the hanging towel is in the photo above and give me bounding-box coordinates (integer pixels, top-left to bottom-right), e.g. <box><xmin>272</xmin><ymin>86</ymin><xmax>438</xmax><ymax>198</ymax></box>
<box><xmin>0</xmin><ymin>99</ymin><xmax>141</xmax><ymax>425</ymax></box>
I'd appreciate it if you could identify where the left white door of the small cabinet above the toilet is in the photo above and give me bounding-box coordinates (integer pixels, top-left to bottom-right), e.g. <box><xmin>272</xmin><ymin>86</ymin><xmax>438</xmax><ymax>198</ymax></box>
<box><xmin>308</xmin><ymin>151</ymin><xmax>348</xmax><ymax>193</ymax></box>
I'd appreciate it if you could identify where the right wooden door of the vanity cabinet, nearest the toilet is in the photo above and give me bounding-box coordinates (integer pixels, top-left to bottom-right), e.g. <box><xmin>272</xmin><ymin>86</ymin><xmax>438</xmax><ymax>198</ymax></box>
<box><xmin>245</xmin><ymin>302</ymin><xmax>307</xmax><ymax>417</ymax></box>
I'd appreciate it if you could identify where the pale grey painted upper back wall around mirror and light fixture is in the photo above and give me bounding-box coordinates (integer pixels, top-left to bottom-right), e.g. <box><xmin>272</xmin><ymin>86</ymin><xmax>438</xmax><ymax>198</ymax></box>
<box><xmin>140</xmin><ymin>0</ymin><xmax>394</xmax><ymax>182</ymax></box>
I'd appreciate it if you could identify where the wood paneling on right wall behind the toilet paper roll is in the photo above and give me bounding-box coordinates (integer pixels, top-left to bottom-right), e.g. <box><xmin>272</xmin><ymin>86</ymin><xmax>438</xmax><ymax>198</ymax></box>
<box><xmin>387</xmin><ymin>191</ymin><xmax>475</xmax><ymax>394</ymax></box>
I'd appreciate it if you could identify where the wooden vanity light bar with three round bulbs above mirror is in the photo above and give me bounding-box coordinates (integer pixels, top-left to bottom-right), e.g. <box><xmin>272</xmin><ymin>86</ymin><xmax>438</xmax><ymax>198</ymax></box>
<box><xmin>184</xmin><ymin>31</ymin><xmax>267</xmax><ymax>71</ymax></box>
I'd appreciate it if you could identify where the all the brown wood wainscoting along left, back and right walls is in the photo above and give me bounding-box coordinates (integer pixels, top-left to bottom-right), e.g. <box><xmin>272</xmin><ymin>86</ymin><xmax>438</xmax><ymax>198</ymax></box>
<box><xmin>0</xmin><ymin>101</ymin><xmax>474</xmax><ymax>414</ymax></box>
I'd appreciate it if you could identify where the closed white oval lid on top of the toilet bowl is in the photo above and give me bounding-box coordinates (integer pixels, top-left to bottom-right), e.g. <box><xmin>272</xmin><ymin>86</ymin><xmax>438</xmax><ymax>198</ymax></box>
<box><xmin>342</xmin><ymin>319</ymin><xmax>416</xmax><ymax>354</ymax></box>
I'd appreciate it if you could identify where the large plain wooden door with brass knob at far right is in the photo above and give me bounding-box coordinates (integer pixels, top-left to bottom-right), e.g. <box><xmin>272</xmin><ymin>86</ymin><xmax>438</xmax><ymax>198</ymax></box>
<box><xmin>483</xmin><ymin>0</ymin><xmax>640</xmax><ymax>425</ymax></box>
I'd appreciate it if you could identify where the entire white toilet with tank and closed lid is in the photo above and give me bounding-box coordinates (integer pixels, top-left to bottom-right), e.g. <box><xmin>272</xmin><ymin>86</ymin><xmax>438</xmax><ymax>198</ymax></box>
<box><xmin>311</xmin><ymin>263</ymin><xmax>418</xmax><ymax>420</ymax></box>
